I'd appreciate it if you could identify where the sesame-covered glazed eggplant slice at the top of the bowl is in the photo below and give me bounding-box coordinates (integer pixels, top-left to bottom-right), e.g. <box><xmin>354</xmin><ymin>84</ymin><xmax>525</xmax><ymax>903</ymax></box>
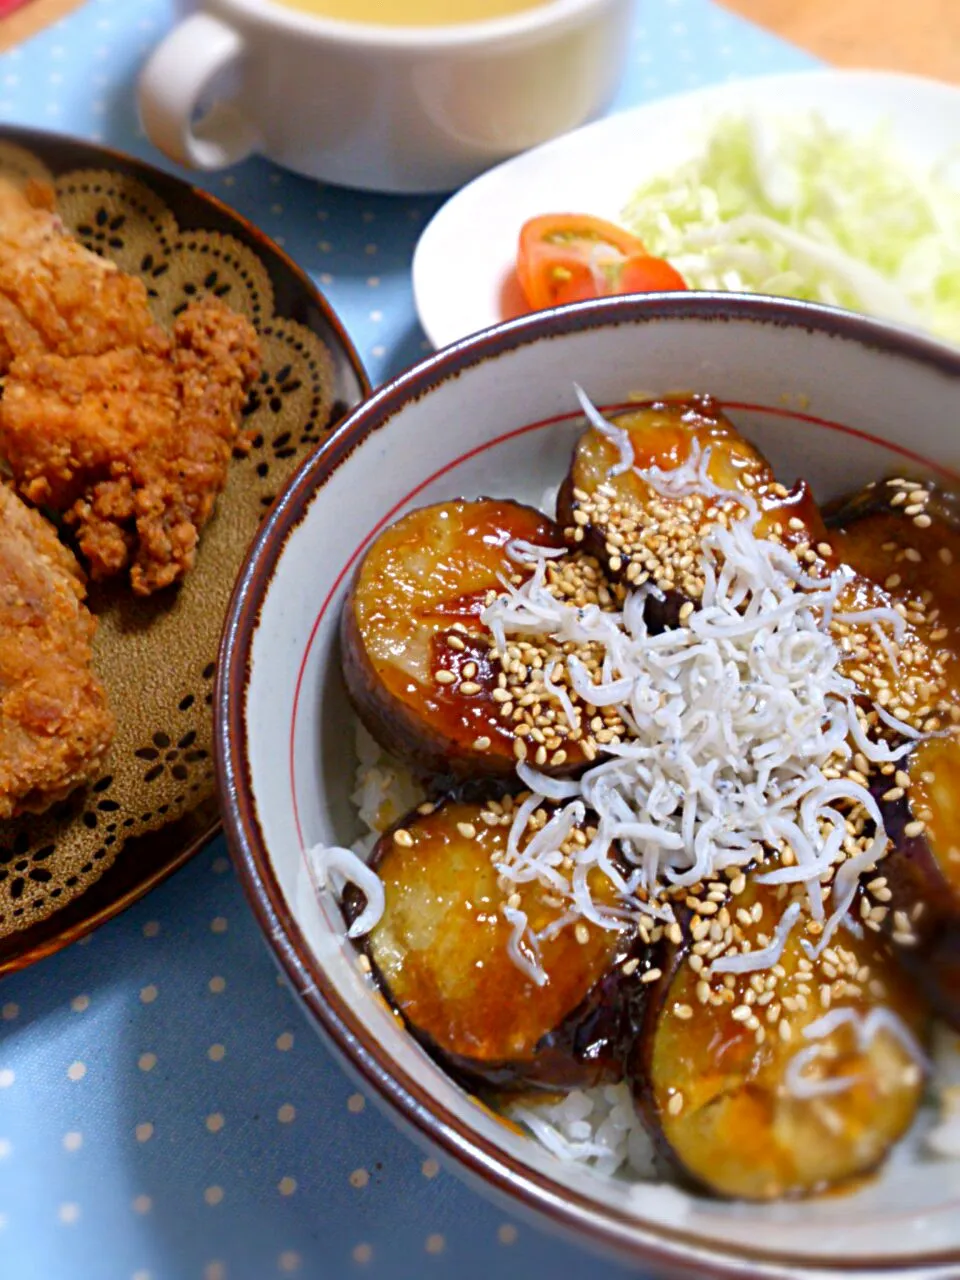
<box><xmin>557</xmin><ymin>397</ymin><xmax>826</xmax><ymax>630</ymax></box>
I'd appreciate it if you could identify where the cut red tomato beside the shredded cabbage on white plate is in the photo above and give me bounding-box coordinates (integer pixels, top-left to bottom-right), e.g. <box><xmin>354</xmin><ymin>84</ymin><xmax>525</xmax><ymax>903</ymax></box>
<box><xmin>517</xmin><ymin>214</ymin><xmax>686</xmax><ymax>311</ymax></box>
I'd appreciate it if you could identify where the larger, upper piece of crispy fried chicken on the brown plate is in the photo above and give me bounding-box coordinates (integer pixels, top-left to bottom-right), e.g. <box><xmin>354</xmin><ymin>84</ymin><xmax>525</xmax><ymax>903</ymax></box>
<box><xmin>0</xmin><ymin>180</ymin><xmax>260</xmax><ymax>595</ymax></box>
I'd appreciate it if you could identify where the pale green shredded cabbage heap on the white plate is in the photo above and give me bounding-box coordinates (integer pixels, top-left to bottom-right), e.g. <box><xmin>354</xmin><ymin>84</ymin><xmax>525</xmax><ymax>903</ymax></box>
<box><xmin>622</xmin><ymin>115</ymin><xmax>960</xmax><ymax>343</ymax></box>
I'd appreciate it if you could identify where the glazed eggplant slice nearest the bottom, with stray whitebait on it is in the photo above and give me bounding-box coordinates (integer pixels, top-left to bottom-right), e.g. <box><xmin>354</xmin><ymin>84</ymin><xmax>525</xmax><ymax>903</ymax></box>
<box><xmin>628</xmin><ymin>886</ymin><xmax>923</xmax><ymax>1201</ymax></box>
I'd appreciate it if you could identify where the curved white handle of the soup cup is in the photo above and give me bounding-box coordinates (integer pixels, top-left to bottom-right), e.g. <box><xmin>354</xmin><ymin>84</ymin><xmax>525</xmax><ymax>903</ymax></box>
<box><xmin>138</xmin><ymin>13</ymin><xmax>260</xmax><ymax>169</ymax></box>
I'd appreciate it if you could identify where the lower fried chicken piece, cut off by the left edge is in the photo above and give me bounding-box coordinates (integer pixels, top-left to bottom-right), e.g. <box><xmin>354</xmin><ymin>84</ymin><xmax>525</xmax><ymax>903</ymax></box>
<box><xmin>0</xmin><ymin>485</ymin><xmax>114</xmax><ymax>819</ymax></box>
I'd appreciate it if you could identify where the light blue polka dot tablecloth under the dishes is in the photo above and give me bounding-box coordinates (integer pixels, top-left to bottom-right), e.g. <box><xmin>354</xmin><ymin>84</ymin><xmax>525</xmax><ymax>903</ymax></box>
<box><xmin>0</xmin><ymin>0</ymin><xmax>812</xmax><ymax>1280</ymax></box>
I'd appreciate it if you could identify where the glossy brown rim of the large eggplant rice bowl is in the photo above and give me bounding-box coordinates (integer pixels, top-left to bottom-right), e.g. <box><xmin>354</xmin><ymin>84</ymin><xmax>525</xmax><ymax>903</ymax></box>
<box><xmin>214</xmin><ymin>293</ymin><xmax>960</xmax><ymax>1280</ymax></box>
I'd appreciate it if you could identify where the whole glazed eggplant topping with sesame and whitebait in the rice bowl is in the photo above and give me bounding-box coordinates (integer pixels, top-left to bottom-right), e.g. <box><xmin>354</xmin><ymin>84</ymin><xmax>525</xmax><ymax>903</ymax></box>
<box><xmin>343</xmin><ymin>396</ymin><xmax>960</xmax><ymax>1201</ymax></box>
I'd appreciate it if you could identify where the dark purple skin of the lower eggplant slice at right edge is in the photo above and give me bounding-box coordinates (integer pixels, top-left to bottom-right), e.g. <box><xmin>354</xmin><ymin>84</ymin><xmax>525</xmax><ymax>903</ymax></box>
<box><xmin>864</xmin><ymin>777</ymin><xmax>960</xmax><ymax>1032</ymax></box>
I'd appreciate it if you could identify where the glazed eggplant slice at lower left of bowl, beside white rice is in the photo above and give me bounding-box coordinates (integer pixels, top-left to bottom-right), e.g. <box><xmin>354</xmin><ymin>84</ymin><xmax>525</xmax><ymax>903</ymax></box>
<box><xmin>344</xmin><ymin>797</ymin><xmax>635</xmax><ymax>1089</ymax></box>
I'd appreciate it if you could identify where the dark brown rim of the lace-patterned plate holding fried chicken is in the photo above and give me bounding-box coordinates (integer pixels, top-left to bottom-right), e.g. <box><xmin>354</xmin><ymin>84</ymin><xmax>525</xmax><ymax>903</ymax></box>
<box><xmin>0</xmin><ymin>124</ymin><xmax>371</xmax><ymax>978</ymax></box>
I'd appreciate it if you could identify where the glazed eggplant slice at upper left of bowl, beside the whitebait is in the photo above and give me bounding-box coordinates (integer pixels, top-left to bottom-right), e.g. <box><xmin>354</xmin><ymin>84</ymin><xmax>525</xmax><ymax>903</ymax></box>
<box><xmin>340</xmin><ymin>498</ymin><xmax>599</xmax><ymax>781</ymax></box>
